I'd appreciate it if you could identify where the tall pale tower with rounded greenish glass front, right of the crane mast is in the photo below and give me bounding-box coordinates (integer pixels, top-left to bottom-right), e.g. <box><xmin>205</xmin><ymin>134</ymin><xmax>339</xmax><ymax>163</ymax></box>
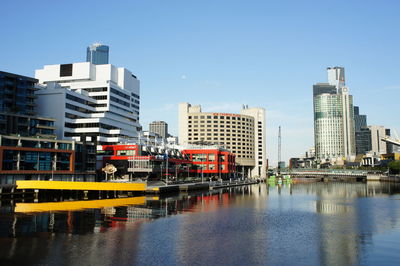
<box><xmin>313</xmin><ymin>67</ymin><xmax>355</xmax><ymax>160</ymax></box>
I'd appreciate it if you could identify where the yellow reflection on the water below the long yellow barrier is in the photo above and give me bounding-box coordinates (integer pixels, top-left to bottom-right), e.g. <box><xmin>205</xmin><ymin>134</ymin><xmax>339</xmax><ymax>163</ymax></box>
<box><xmin>15</xmin><ymin>197</ymin><xmax>146</xmax><ymax>212</ymax></box>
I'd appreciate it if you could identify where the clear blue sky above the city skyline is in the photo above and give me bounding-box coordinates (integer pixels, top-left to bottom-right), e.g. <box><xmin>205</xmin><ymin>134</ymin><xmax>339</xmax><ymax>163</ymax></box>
<box><xmin>0</xmin><ymin>0</ymin><xmax>400</xmax><ymax>164</ymax></box>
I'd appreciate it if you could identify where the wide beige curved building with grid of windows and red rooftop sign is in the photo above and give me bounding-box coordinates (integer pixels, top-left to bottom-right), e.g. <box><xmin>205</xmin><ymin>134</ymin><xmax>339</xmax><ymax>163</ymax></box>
<box><xmin>179</xmin><ymin>103</ymin><xmax>267</xmax><ymax>177</ymax></box>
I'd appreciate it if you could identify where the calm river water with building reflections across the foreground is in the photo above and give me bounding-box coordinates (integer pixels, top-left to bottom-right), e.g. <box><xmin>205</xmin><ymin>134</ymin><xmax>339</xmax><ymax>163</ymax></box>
<box><xmin>0</xmin><ymin>183</ymin><xmax>400</xmax><ymax>265</ymax></box>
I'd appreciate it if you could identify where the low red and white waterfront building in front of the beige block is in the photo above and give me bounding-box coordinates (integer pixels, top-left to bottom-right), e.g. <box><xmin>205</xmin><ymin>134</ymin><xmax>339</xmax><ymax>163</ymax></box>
<box><xmin>101</xmin><ymin>144</ymin><xmax>236</xmax><ymax>180</ymax></box>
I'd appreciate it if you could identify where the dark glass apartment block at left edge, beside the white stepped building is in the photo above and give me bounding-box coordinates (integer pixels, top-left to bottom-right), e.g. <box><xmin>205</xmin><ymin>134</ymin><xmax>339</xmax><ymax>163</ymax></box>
<box><xmin>0</xmin><ymin>71</ymin><xmax>55</xmax><ymax>139</ymax></box>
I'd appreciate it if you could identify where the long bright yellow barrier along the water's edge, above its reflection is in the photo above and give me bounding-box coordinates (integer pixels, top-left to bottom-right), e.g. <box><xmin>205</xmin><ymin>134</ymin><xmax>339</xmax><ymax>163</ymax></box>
<box><xmin>16</xmin><ymin>180</ymin><xmax>146</xmax><ymax>191</ymax></box>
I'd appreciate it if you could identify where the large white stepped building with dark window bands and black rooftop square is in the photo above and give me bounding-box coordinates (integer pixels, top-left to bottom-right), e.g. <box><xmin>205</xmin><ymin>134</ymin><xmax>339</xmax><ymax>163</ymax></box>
<box><xmin>35</xmin><ymin>62</ymin><xmax>140</xmax><ymax>148</ymax></box>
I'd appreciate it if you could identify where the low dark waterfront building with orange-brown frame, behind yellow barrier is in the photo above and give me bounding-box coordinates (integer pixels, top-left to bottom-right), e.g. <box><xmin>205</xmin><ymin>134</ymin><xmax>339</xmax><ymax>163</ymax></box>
<box><xmin>0</xmin><ymin>135</ymin><xmax>96</xmax><ymax>186</ymax></box>
